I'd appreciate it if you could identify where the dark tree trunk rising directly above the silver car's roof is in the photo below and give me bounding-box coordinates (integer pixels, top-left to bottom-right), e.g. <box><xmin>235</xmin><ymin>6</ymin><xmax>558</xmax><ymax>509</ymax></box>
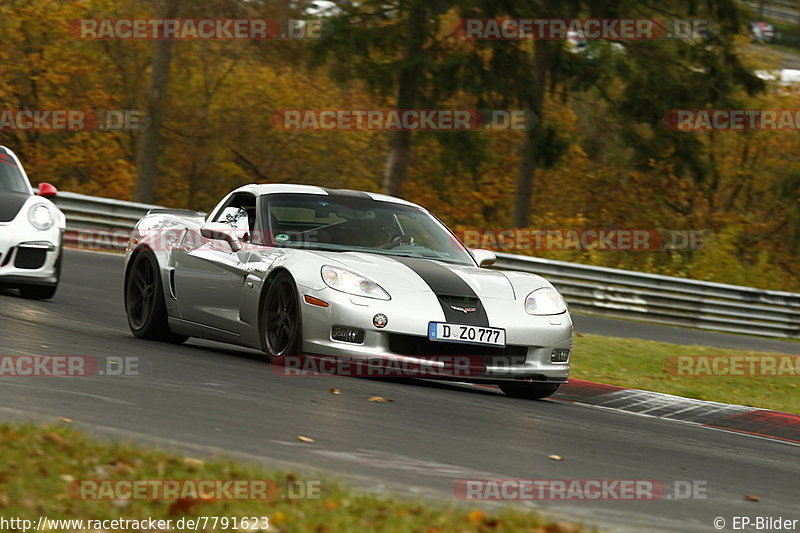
<box><xmin>383</xmin><ymin>0</ymin><xmax>428</xmax><ymax>196</ymax></box>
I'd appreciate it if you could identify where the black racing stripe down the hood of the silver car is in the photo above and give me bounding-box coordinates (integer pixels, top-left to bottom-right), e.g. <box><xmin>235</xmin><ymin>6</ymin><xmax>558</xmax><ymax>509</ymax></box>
<box><xmin>392</xmin><ymin>255</ymin><xmax>489</xmax><ymax>326</ymax></box>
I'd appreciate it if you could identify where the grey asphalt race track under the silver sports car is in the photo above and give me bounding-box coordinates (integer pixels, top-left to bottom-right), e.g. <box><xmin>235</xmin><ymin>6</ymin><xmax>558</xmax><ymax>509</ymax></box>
<box><xmin>0</xmin><ymin>251</ymin><xmax>800</xmax><ymax>531</ymax></box>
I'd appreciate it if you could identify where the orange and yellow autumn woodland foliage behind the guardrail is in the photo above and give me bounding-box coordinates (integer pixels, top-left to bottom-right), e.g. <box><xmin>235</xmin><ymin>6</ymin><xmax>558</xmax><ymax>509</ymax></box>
<box><xmin>0</xmin><ymin>0</ymin><xmax>800</xmax><ymax>291</ymax></box>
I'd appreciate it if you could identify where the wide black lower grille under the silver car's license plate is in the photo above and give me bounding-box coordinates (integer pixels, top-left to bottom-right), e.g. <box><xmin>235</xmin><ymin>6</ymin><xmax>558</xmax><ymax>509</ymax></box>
<box><xmin>389</xmin><ymin>333</ymin><xmax>528</xmax><ymax>366</ymax></box>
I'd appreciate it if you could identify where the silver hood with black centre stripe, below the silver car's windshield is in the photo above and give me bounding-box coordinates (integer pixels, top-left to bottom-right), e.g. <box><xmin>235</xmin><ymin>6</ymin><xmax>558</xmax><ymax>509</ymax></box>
<box><xmin>306</xmin><ymin>251</ymin><xmax>514</xmax><ymax>300</ymax></box>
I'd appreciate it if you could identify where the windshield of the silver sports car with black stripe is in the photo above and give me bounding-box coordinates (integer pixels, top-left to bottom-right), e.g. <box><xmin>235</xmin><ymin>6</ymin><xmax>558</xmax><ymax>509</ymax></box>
<box><xmin>263</xmin><ymin>194</ymin><xmax>475</xmax><ymax>266</ymax></box>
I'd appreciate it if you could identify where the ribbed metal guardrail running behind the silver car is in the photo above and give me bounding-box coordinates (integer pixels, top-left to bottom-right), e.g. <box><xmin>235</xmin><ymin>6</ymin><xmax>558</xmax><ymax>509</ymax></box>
<box><xmin>55</xmin><ymin>192</ymin><xmax>800</xmax><ymax>339</ymax></box>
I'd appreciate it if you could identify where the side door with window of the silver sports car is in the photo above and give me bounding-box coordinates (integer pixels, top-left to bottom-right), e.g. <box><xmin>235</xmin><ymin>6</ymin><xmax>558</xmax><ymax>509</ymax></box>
<box><xmin>173</xmin><ymin>193</ymin><xmax>256</xmax><ymax>335</ymax></box>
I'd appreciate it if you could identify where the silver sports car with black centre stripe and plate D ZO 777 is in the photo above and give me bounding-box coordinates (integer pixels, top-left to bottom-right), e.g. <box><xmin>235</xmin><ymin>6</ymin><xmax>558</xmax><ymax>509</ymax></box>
<box><xmin>125</xmin><ymin>184</ymin><xmax>573</xmax><ymax>398</ymax></box>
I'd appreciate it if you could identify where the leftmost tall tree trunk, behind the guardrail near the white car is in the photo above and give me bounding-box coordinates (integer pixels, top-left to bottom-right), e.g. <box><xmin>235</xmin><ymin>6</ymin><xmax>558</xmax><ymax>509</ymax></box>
<box><xmin>133</xmin><ymin>0</ymin><xmax>179</xmax><ymax>203</ymax></box>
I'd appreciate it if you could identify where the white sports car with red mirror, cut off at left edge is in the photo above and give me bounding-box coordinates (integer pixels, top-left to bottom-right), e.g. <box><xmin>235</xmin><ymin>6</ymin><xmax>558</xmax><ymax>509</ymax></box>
<box><xmin>0</xmin><ymin>146</ymin><xmax>66</xmax><ymax>299</ymax></box>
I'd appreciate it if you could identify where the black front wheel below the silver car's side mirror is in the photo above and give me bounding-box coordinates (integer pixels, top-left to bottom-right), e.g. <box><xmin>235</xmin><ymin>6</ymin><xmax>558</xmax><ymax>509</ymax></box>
<box><xmin>261</xmin><ymin>271</ymin><xmax>302</xmax><ymax>362</ymax></box>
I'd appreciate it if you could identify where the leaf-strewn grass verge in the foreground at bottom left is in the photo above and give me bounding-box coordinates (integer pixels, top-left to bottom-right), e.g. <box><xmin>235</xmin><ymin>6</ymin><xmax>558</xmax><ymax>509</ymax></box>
<box><xmin>0</xmin><ymin>424</ymin><xmax>585</xmax><ymax>533</ymax></box>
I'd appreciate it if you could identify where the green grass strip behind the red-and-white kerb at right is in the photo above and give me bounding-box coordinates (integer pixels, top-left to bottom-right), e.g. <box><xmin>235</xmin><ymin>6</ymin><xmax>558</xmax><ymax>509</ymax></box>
<box><xmin>570</xmin><ymin>333</ymin><xmax>800</xmax><ymax>413</ymax></box>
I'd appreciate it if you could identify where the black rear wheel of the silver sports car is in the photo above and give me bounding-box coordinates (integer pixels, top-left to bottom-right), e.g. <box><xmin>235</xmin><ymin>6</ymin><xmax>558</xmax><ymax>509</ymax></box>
<box><xmin>125</xmin><ymin>251</ymin><xmax>189</xmax><ymax>344</ymax></box>
